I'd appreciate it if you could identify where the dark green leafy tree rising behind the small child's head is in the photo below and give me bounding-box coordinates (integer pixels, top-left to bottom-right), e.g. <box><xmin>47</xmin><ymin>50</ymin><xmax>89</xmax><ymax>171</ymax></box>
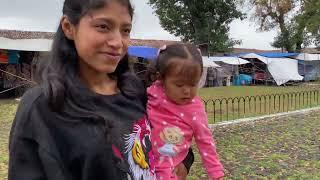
<box><xmin>149</xmin><ymin>0</ymin><xmax>243</xmax><ymax>52</ymax></box>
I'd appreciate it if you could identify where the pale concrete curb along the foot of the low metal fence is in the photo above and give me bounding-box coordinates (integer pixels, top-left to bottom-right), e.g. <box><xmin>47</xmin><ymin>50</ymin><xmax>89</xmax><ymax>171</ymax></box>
<box><xmin>209</xmin><ymin>107</ymin><xmax>320</xmax><ymax>129</ymax></box>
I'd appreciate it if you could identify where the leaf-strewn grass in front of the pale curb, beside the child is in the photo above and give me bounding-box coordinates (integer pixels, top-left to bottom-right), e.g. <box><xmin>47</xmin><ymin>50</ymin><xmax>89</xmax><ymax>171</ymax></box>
<box><xmin>188</xmin><ymin>112</ymin><xmax>320</xmax><ymax>180</ymax></box>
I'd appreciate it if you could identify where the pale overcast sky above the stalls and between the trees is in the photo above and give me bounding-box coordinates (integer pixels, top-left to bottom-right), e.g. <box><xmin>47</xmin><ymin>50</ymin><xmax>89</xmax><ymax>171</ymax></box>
<box><xmin>0</xmin><ymin>0</ymin><xmax>276</xmax><ymax>49</ymax></box>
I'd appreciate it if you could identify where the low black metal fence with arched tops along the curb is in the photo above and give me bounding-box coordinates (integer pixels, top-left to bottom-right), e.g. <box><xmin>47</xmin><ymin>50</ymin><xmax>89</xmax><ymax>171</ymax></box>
<box><xmin>203</xmin><ymin>90</ymin><xmax>320</xmax><ymax>123</ymax></box>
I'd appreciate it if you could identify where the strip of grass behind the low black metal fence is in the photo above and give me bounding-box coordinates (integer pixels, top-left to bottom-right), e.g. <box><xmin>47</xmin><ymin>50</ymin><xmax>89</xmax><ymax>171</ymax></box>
<box><xmin>199</xmin><ymin>85</ymin><xmax>320</xmax><ymax>123</ymax></box>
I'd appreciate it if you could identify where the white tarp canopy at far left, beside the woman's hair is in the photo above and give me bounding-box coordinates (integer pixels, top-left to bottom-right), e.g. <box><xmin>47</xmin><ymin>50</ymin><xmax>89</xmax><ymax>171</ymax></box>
<box><xmin>0</xmin><ymin>37</ymin><xmax>52</xmax><ymax>51</ymax></box>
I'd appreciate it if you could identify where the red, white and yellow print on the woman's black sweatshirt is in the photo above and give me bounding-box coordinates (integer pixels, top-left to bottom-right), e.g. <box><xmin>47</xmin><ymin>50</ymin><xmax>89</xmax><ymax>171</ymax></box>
<box><xmin>125</xmin><ymin>117</ymin><xmax>156</xmax><ymax>180</ymax></box>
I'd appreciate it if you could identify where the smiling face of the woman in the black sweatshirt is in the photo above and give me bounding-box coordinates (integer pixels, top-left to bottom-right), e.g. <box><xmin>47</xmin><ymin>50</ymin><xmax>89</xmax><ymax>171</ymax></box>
<box><xmin>69</xmin><ymin>1</ymin><xmax>132</xmax><ymax>74</ymax></box>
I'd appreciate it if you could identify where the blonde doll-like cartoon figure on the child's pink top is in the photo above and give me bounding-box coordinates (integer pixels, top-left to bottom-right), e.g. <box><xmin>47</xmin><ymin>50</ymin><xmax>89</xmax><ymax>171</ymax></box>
<box><xmin>158</xmin><ymin>126</ymin><xmax>184</xmax><ymax>166</ymax></box>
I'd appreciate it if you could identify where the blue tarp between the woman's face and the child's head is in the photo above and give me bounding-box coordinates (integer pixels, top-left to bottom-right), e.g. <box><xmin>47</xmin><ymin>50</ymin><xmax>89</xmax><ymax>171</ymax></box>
<box><xmin>128</xmin><ymin>46</ymin><xmax>158</xmax><ymax>59</ymax></box>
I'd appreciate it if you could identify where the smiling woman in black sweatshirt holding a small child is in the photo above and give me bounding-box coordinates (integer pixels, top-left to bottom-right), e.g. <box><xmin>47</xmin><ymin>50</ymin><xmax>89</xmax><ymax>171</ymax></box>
<box><xmin>9</xmin><ymin>0</ymin><xmax>192</xmax><ymax>180</ymax></box>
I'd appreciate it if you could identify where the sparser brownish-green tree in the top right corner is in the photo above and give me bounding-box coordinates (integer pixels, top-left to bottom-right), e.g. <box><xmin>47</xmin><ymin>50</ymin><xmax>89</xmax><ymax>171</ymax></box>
<box><xmin>249</xmin><ymin>0</ymin><xmax>320</xmax><ymax>52</ymax></box>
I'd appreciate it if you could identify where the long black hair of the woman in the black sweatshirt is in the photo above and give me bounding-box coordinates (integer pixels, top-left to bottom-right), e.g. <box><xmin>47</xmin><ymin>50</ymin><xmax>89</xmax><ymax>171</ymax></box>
<box><xmin>39</xmin><ymin>0</ymin><xmax>133</xmax><ymax>110</ymax></box>
